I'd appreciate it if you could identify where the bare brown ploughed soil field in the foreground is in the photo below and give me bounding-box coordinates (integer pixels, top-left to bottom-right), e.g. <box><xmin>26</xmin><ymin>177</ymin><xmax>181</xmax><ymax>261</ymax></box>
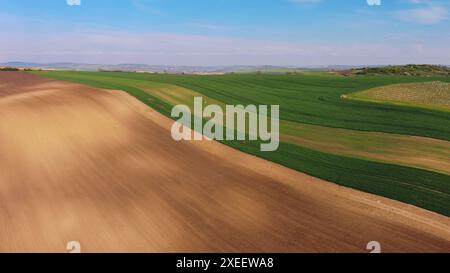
<box><xmin>0</xmin><ymin>72</ymin><xmax>450</xmax><ymax>252</ymax></box>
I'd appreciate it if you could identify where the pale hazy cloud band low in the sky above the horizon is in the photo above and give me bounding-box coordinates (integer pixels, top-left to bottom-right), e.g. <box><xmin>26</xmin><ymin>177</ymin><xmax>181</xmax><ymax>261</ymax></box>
<box><xmin>0</xmin><ymin>28</ymin><xmax>450</xmax><ymax>65</ymax></box>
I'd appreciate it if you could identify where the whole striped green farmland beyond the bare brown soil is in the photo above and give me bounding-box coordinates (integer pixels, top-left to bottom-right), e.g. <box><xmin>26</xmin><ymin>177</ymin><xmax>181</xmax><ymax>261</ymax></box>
<box><xmin>36</xmin><ymin>71</ymin><xmax>450</xmax><ymax>216</ymax></box>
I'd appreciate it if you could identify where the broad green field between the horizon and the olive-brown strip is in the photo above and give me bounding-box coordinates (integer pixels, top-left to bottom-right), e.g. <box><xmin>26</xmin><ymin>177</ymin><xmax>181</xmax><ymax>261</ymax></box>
<box><xmin>70</xmin><ymin>72</ymin><xmax>450</xmax><ymax>140</ymax></box>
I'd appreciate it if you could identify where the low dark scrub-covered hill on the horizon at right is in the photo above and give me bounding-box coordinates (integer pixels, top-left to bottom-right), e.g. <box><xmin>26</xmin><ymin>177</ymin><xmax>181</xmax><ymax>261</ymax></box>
<box><xmin>349</xmin><ymin>64</ymin><xmax>450</xmax><ymax>76</ymax></box>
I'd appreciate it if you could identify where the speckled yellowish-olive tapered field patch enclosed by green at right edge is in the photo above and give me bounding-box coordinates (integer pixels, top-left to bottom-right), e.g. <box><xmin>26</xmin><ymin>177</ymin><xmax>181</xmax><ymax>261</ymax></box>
<box><xmin>348</xmin><ymin>81</ymin><xmax>450</xmax><ymax>111</ymax></box>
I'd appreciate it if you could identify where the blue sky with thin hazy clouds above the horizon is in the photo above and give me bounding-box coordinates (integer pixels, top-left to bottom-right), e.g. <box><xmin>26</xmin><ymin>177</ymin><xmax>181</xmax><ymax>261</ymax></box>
<box><xmin>0</xmin><ymin>0</ymin><xmax>450</xmax><ymax>66</ymax></box>
